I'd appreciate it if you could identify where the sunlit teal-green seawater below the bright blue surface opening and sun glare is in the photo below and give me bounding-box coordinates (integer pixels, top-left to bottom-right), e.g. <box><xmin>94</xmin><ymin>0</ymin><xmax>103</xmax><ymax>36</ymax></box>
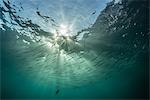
<box><xmin>0</xmin><ymin>0</ymin><xmax>149</xmax><ymax>99</ymax></box>
